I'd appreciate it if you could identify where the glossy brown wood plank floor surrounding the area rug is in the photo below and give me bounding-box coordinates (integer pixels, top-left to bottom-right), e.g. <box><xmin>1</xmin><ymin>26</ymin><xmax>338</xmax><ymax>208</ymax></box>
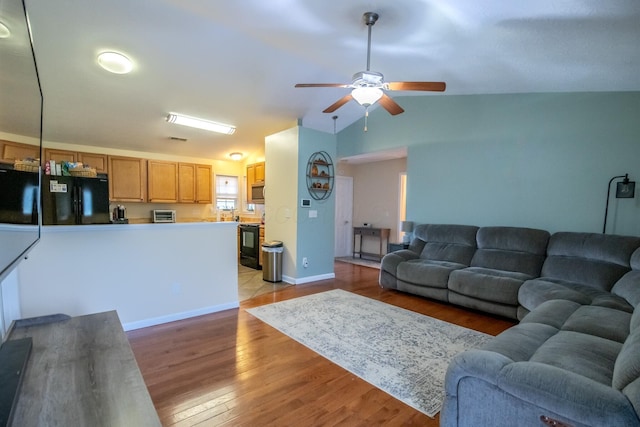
<box><xmin>127</xmin><ymin>262</ymin><xmax>514</xmax><ymax>427</ymax></box>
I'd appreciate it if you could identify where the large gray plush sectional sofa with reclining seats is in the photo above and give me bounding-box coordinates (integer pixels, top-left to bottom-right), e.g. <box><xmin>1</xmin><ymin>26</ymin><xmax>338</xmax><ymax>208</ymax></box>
<box><xmin>380</xmin><ymin>224</ymin><xmax>640</xmax><ymax>427</ymax></box>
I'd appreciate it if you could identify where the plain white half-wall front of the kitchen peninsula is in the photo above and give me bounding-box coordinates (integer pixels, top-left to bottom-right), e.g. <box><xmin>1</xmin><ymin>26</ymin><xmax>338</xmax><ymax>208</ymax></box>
<box><xmin>18</xmin><ymin>222</ymin><xmax>239</xmax><ymax>330</ymax></box>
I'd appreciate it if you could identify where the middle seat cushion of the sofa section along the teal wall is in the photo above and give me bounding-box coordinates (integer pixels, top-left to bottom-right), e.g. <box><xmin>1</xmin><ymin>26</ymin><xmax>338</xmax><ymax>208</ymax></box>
<box><xmin>449</xmin><ymin>267</ymin><xmax>531</xmax><ymax>305</ymax></box>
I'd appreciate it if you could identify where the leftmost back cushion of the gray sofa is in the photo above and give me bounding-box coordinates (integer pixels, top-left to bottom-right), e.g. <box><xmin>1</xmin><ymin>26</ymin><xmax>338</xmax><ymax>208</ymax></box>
<box><xmin>414</xmin><ymin>224</ymin><xmax>478</xmax><ymax>265</ymax></box>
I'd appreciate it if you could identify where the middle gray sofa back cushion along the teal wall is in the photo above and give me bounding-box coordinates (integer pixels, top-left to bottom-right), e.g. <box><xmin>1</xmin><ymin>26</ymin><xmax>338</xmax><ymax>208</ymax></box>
<box><xmin>471</xmin><ymin>227</ymin><xmax>549</xmax><ymax>277</ymax></box>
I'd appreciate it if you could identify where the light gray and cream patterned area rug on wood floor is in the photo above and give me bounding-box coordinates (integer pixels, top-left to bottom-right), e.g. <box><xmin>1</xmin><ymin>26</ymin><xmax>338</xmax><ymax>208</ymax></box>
<box><xmin>247</xmin><ymin>289</ymin><xmax>491</xmax><ymax>417</ymax></box>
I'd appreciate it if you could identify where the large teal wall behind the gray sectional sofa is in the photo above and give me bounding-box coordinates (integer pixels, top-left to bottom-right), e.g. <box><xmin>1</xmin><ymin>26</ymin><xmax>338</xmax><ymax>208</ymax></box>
<box><xmin>338</xmin><ymin>92</ymin><xmax>640</xmax><ymax>235</ymax></box>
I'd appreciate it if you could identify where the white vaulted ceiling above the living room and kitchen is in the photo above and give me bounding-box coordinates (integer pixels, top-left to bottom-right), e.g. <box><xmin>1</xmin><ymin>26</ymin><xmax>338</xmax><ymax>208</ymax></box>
<box><xmin>5</xmin><ymin>0</ymin><xmax>640</xmax><ymax>159</ymax></box>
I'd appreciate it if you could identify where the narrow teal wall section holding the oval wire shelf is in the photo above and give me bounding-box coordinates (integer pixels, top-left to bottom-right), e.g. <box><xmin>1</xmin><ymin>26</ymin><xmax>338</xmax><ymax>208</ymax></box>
<box><xmin>296</xmin><ymin>127</ymin><xmax>336</xmax><ymax>278</ymax></box>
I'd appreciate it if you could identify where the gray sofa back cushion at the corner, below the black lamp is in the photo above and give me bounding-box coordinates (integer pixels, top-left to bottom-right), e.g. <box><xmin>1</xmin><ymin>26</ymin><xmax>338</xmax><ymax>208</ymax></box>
<box><xmin>542</xmin><ymin>232</ymin><xmax>640</xmax><ymax>291</ymax></box>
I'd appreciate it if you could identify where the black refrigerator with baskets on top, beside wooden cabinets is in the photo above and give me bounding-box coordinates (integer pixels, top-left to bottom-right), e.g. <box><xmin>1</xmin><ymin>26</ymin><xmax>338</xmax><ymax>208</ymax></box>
<box><xmin>42</xmin><ymin>175</ymin><xmax>111</xmax><ymax>225</ymax></box>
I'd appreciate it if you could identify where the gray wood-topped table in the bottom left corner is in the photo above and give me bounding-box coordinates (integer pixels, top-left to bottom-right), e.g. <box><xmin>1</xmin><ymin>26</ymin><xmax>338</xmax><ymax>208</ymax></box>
<box><xmin>9</xmin><ymin>311</ymin><xmax>161</xmax><ymax>426</ymax></box>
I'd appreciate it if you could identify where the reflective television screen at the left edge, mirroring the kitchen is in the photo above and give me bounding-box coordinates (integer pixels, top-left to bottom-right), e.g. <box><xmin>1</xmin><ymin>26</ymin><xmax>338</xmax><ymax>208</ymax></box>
<box><xmin>0</xmin><ymin>0</ymin><xmax>42</xmax><ymax>280</ymax></box>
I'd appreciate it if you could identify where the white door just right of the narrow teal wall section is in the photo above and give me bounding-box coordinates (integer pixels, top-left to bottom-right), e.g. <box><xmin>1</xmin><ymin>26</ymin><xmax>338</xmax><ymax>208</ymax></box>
<box><xmin>334</xmin><ymin>176</ymin><xmax>353</xmax><ymax>257</ymax></box>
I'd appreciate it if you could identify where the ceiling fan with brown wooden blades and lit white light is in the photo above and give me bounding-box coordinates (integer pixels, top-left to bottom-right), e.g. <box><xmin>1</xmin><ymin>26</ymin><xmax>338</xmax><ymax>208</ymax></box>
<box><xmin>295</xmin><ymin>12</ymin><xmax>446</xmax><ymax>121</ymax></box>
